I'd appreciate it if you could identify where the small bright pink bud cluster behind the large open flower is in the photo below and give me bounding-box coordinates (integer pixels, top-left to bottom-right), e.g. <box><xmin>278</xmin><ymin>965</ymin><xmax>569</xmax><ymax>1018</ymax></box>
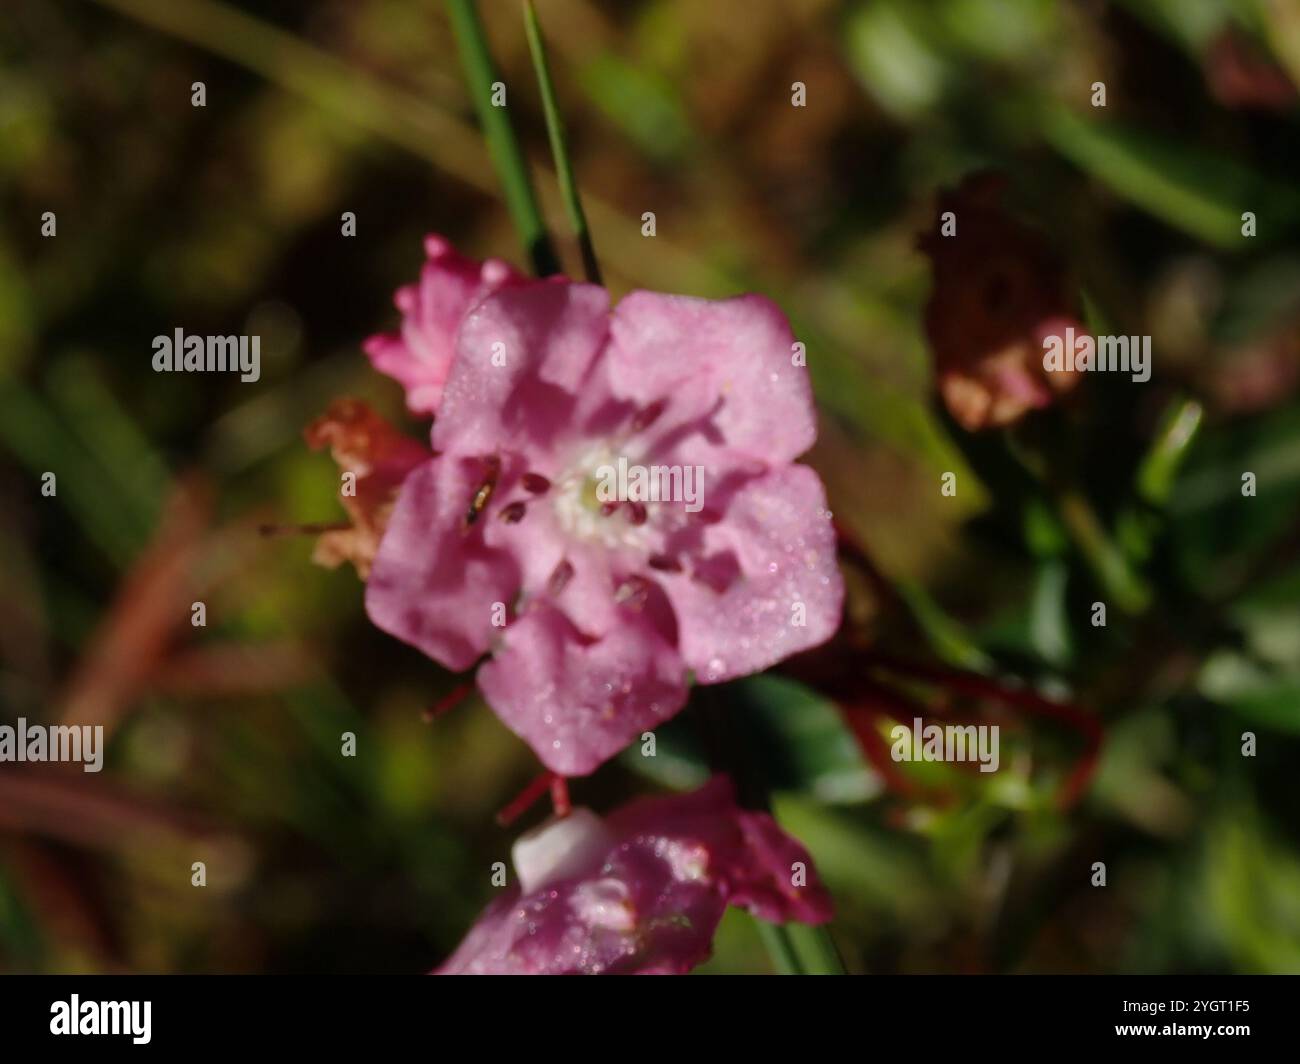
<box><xmin>364</xmin><ymin>235</ymin><xmax>519</xmax><ymax>414</ymax></box>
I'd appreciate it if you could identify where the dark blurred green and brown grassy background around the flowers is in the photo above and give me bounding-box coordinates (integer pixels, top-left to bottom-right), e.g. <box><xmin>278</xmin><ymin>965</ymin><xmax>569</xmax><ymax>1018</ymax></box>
<box><xmin>0</xmin><ymin>0</ymin><xmax>1300</xmax><ymax>972</ymax></box>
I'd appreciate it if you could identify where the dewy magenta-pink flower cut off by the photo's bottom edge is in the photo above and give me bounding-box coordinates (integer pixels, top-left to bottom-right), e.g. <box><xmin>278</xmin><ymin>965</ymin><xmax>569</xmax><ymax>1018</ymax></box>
<box><xmin>436</xmin><ymin>777</ymin><xmax>831</xmax><ymax>976</ymax></box>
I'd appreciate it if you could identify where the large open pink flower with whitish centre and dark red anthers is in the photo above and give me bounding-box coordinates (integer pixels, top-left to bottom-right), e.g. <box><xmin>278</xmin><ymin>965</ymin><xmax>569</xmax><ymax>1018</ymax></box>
<box><xmin>365</xmin><ymin>257</ymin><xmax>844</xmax><ymax>775</ymax></box>
